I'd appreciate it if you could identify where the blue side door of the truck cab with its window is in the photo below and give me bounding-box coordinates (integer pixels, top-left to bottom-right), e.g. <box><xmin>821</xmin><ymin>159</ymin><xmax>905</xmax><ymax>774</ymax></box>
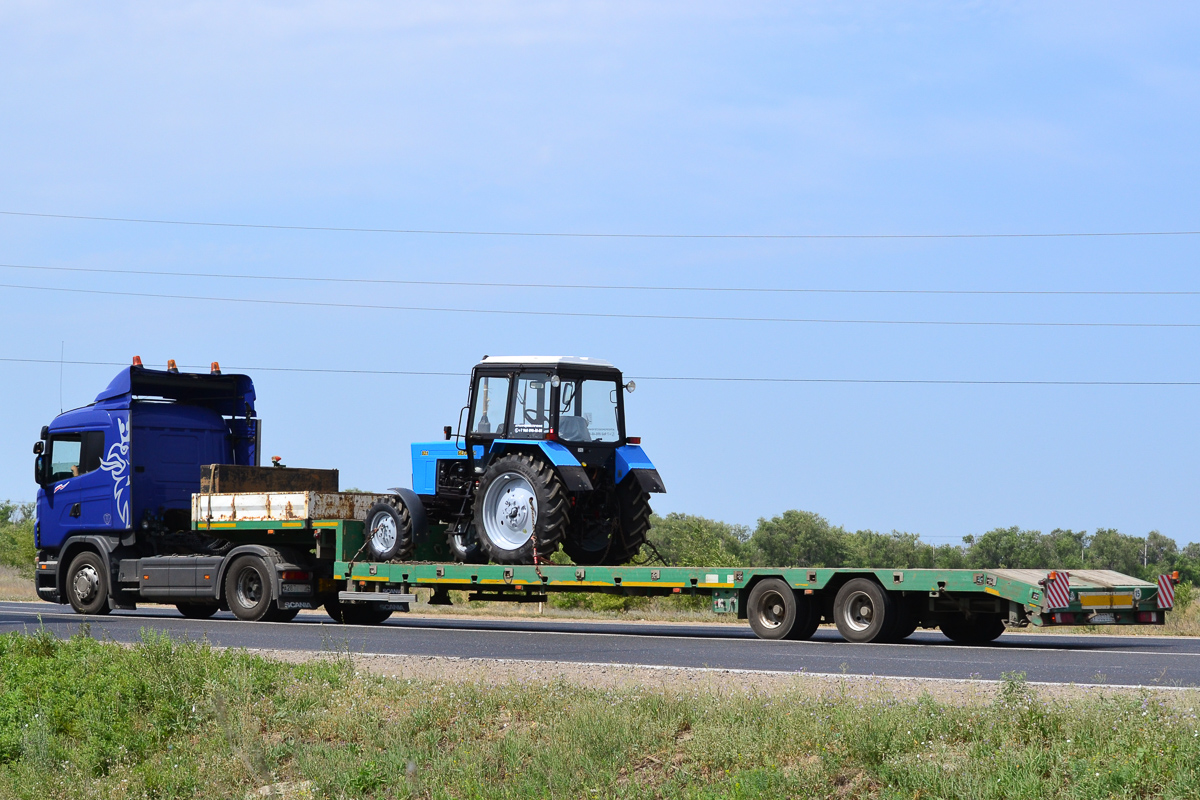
<box><xmin>38</xmin><ymin>431</ymin><xmax>124</xmax><ymax>547</ymax></box>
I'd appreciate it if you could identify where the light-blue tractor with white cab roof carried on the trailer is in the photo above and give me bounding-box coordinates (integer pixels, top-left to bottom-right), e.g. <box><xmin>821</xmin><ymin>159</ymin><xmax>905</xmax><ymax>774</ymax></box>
<box><xmin>408</xmin><ymin>356</ymin><xmax>666</xmax><ymax>565</ymax></box>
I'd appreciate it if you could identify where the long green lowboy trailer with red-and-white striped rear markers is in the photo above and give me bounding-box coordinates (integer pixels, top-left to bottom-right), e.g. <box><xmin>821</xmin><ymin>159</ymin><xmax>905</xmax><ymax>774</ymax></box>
<box><xmin>194</xmin><ymin>495</ymin><xmax>1177</xmax><ymax>642</ymax></box>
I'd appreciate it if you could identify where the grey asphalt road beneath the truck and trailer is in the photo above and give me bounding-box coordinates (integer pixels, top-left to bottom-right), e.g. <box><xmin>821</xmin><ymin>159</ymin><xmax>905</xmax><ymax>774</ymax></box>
<box><xmin>0</xmin><ymin>602</ymin><xmax>1200</xmax><ymax>686</ymax></box>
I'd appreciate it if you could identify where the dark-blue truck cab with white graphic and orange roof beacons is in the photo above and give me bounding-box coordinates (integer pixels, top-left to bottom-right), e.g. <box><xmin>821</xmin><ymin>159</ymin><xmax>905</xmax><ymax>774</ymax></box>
<box><xmin>34</xmin><ymin>360</ymin><xmax>262</xmax><ymax>604</ymax></box>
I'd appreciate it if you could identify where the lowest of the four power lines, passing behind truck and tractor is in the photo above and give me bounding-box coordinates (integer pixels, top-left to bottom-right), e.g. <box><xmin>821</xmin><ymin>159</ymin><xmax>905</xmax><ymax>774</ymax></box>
<box><xmin>0</xmin><ymin>357</ymin><xmax>1200</xmax><ymax>386</ymax></box>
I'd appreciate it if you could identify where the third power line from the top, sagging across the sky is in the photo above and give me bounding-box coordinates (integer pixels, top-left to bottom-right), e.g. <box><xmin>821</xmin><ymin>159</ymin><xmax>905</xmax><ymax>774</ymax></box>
<box><xmin>0</xmin><ymin>283</ymin><xmax>1200</xmax><ymax>329</ymax></box>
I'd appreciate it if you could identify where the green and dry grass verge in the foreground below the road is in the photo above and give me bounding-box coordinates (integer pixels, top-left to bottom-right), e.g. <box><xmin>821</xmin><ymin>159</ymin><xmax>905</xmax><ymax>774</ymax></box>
<box><xmin>0</xmin><ymin>632</ymin><xmax>1200</xmax><ymax>800</ymax></box>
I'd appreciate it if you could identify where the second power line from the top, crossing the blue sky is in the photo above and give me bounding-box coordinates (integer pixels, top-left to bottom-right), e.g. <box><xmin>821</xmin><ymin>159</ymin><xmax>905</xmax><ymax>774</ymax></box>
<box><xmin>0</xmin><ymin>264</ymin><xmax>1200</xmax><ymax>296</ymax></box>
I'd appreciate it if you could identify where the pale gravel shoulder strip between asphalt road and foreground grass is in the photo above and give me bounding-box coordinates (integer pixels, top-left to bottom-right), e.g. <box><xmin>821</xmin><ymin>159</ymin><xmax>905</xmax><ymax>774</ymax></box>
<box><xmin>243</xmin><ymin>650</ymin><xmax>1200</xmax><ymax>705</ymax></box>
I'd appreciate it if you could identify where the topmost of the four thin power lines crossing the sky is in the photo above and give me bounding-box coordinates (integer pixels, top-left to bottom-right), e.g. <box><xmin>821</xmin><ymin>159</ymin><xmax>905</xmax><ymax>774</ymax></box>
<box><xmin>0</xmin><ymin>211</ymin><xmax>1200</xmax><ymax>240</ymax></box>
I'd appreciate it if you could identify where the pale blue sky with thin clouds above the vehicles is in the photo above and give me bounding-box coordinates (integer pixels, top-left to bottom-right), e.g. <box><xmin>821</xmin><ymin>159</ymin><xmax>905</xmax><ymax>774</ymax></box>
<box><xmin>0</xmin><ymin>2</ymin><xmax>1200</xmax><ymax>542</ymax></box>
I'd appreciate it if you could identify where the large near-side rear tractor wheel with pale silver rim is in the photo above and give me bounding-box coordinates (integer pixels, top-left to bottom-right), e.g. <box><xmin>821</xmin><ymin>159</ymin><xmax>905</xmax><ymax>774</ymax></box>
<box><xmin>474</xmin><ymin>453</ymin><xmax>568</xmax><ymax>564</ymax></box>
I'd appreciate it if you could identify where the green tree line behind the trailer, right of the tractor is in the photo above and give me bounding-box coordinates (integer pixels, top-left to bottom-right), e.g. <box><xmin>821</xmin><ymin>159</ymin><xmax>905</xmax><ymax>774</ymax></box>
<box><xmin>650</xmin><ymin>511</ymin><xmax>1200</xmax><ymax>583</ymax></box>
